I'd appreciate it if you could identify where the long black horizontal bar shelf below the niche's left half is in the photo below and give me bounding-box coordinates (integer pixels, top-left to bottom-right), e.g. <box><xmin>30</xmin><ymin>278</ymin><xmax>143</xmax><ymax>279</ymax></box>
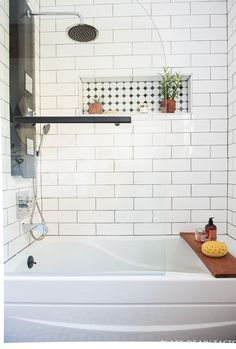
<box><xmin>14</xmin><ymin>115</ymin><xmax>131</xmax><ymax>125</ymax></box>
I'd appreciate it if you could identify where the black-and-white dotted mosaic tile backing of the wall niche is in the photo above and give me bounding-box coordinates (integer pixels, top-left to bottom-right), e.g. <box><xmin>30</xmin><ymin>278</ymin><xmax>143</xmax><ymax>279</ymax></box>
<box><xmin>80</xmin><ymin>76</ymin><xmax>190</xmax><ymax>114</ymax></box>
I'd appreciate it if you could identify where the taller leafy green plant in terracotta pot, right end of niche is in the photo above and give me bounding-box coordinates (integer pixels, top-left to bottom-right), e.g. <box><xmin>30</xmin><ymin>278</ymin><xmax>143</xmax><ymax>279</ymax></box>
<box><xmin>159</xmin><ymin>67</ymin><xmax>183</xmax><ymax>113</ymax></box>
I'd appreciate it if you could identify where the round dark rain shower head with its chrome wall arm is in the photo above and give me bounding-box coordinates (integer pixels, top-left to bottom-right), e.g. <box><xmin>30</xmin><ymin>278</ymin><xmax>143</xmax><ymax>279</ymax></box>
<box><xmin>27</xmin><ymin>10</ymin><xmax>99</xmax><ymax>42</ymax></box>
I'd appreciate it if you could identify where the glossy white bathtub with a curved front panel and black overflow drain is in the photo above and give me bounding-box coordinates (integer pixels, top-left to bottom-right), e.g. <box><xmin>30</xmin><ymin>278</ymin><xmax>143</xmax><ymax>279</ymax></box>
<box><xmin>5</xmin><ymin>236</ymin><xmax>236</xmax><ymax>342</ymax></box>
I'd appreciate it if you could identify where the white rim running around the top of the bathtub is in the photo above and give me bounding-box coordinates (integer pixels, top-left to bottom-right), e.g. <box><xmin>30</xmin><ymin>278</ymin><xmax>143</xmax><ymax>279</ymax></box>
<box><xmin>4</xmin><ymin>234</ymin><xmax>236</xmax><ymax>280</ymax></box>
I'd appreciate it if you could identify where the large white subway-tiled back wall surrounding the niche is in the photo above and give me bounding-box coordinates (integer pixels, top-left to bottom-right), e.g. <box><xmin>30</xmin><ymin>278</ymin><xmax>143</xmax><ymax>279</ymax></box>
<box><xmin>40</xmin><ymin>0</ymin><xmax>229</xmax><ymax>235</ymax></box>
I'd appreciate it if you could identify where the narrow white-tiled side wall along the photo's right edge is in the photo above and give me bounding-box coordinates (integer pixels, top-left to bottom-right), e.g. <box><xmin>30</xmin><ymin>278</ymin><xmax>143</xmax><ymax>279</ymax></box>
<box><xmin>228</xmin><ymin>0</ymin><xmax>236</xmax><ymax>239</ymax></box>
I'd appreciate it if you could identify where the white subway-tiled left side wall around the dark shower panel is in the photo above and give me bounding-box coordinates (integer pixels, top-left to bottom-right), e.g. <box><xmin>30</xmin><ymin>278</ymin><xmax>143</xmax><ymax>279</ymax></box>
<box><xmin>0</xmin><ymin>0</ymin><xmax>40</xmax><ymax>260</ymax></box>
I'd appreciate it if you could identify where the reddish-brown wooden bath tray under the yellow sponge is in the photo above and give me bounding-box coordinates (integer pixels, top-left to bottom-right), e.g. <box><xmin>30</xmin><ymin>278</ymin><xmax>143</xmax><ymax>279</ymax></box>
<box><xmin>180</xmin><ymin>233</ymin><xmax>236</xmax><ymax>278</ymax></box>
